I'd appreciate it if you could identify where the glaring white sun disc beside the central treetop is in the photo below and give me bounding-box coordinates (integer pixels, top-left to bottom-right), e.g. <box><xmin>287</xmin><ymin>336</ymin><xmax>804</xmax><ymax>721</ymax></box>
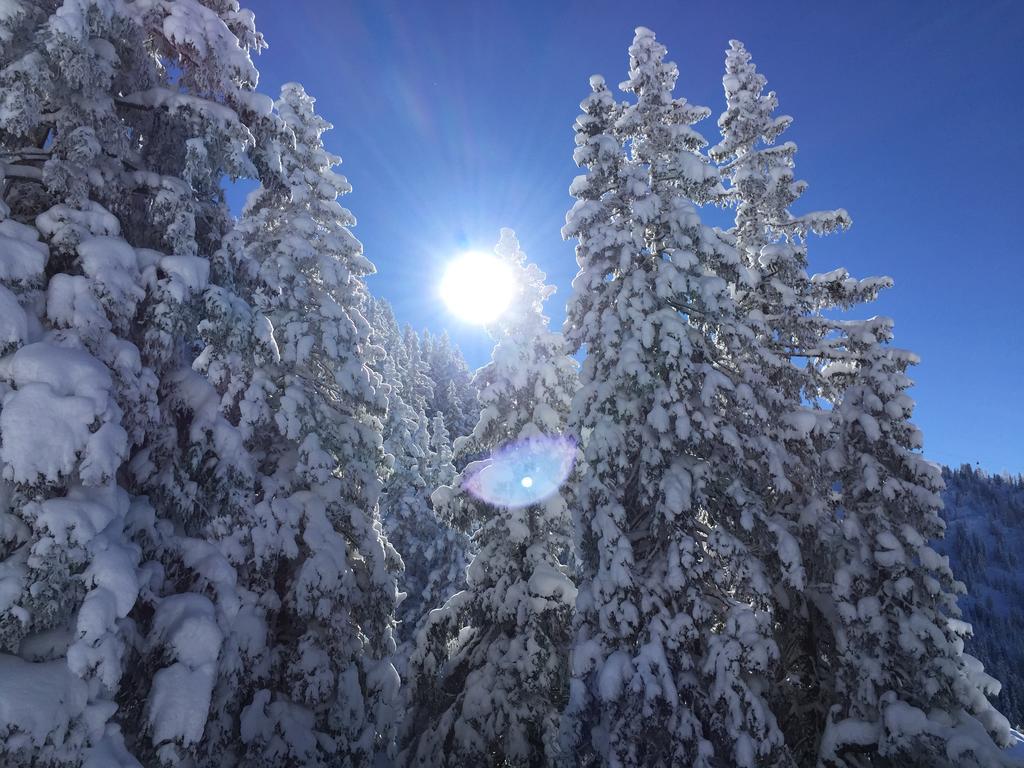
<box><xmin>441</xmin><ymin>253</ymin><xmax>515</xmax><ymax>326</ymax></box>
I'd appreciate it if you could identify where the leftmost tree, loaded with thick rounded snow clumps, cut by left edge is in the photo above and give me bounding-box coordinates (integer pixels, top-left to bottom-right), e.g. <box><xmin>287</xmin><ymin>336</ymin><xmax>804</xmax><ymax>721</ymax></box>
<box><xmin>0</xmin><ymin>3</ymin><xmax>149</xmax><ymax>765</ymax></box>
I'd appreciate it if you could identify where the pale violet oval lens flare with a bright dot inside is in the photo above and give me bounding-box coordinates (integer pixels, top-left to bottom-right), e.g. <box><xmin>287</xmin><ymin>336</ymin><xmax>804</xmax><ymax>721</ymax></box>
<box><xmin>463</xmin><ymin>435</ymin><xmax>577</xmax><ymax>509</ymax></box>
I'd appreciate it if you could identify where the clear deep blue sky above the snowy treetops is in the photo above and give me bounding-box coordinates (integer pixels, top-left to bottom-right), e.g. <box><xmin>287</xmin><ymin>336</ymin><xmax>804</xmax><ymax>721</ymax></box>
<box><xmin>235</xmin><ymin>0</ymin><xmax>1024</xmax><ymax>472</ymax></box>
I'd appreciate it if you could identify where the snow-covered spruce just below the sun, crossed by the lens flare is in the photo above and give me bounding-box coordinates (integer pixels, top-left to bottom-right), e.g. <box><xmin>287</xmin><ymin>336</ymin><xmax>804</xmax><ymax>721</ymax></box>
<box><xmin>400</xmin><ymin>229</ymin><xmax>577</xmax><ymax>766</ymax></box>
